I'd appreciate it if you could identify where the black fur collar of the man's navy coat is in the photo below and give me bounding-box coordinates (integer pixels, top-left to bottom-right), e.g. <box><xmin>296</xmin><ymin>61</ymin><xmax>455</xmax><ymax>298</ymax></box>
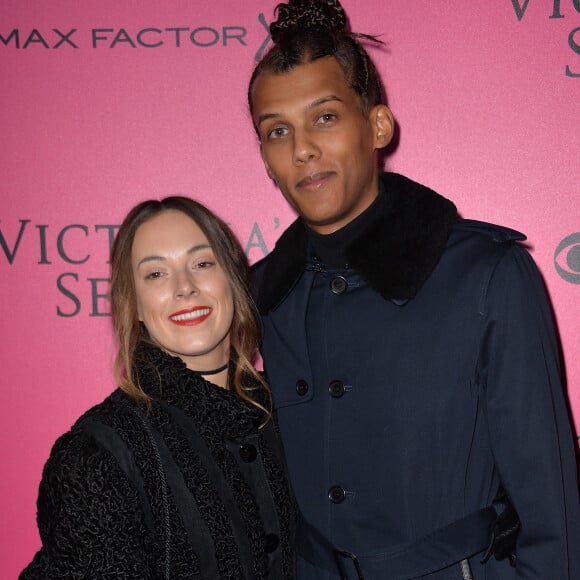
<box><xmin>257</xmin><ymin>173</ymin><xmax>457</xmax><ymax>314</ymax></box>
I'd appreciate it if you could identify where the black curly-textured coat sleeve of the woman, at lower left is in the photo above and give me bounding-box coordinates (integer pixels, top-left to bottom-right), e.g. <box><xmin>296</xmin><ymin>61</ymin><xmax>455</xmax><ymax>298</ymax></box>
<box><xmin>20</xmin><ymin>431</ymin><xmax>152</xmax><ymax>580</ymax></box>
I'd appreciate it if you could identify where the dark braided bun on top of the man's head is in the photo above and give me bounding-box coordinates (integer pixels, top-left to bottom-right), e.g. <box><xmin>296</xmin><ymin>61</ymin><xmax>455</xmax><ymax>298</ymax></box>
<box><xmin>270</xmin><ymin>0</ymin><xmax>347</xmax><ymax>44</ymax></box>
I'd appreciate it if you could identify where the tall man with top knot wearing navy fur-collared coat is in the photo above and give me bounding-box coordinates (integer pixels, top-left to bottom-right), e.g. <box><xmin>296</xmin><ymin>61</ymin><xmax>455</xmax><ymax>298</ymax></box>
<box><xmin>249</xmin><ymin>0</ymin><xmax>580</xmax><ymax>580</ymax></box>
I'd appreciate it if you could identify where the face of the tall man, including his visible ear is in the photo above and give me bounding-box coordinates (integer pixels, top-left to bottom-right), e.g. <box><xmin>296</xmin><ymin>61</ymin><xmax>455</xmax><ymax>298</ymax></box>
<box><xmin>252</xmin><ymin>57</ymin><xmax>393</xmax><ymax>234</ymax></box>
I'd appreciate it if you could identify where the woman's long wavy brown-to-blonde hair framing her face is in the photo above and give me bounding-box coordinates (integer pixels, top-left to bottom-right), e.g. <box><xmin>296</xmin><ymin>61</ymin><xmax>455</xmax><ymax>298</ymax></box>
<box><xmin>110</xmin><ymin>196</ymin><xmax>272</xmax><ymax>416</ymax></box>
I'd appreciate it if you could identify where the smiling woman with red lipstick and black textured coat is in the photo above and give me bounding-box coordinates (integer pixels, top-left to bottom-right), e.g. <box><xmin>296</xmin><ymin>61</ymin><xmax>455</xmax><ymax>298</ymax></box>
<box><xmin>21</xmin><ymin>197</ymin><xmax>295</xmax><ymax>580</ymax></box>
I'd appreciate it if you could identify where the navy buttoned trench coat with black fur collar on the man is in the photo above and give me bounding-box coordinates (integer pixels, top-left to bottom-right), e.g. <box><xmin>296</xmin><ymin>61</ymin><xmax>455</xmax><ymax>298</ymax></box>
<box><xmin>255</xmin><ymin>174</ymin><xmax>580</xmax><ymax>580</ymax></box>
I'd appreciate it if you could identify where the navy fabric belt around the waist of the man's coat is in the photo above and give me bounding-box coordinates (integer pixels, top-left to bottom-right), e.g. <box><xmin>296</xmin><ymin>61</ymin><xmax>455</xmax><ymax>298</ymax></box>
<box><xmin>296</xmin><ymin>507</ymin><xmax>497</xmax><ymax>580</ymax></box>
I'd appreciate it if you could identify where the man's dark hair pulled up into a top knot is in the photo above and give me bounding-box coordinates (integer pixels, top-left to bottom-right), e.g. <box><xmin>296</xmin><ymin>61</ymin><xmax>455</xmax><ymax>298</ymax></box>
<box><xmin>248</xmin><ymin>0</ymin><xmax>384</xmax><ymax>125</ymax></box>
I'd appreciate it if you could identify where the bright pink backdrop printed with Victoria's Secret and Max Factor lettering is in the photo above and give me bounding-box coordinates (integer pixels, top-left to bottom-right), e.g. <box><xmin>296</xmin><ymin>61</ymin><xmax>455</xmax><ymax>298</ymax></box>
<box><xmin>0</xmin><ymin>0</ymin><xmax>580</xmax><ymax>579</ymax></box>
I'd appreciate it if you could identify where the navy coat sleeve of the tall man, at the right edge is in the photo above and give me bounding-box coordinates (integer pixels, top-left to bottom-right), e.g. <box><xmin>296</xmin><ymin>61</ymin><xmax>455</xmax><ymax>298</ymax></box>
<box><xmin>482</xmin><ymin>245</ymin><xmax>580</xmax><ymax>580</ymax></box>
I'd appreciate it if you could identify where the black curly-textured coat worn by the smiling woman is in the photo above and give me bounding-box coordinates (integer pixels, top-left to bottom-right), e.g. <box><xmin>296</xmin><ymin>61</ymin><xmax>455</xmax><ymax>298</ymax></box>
<box><xmin>21</xmin><ymin>347</ymin><xmax>295</xmax><ymax>580</ymax></box>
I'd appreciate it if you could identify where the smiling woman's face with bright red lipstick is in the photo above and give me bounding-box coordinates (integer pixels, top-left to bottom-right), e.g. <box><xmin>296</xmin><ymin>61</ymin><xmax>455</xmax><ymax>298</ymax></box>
<box><xmin>131</xmin><ymin>210</ymin><xmax>234</xmax><ymax>371</ymax></box>
